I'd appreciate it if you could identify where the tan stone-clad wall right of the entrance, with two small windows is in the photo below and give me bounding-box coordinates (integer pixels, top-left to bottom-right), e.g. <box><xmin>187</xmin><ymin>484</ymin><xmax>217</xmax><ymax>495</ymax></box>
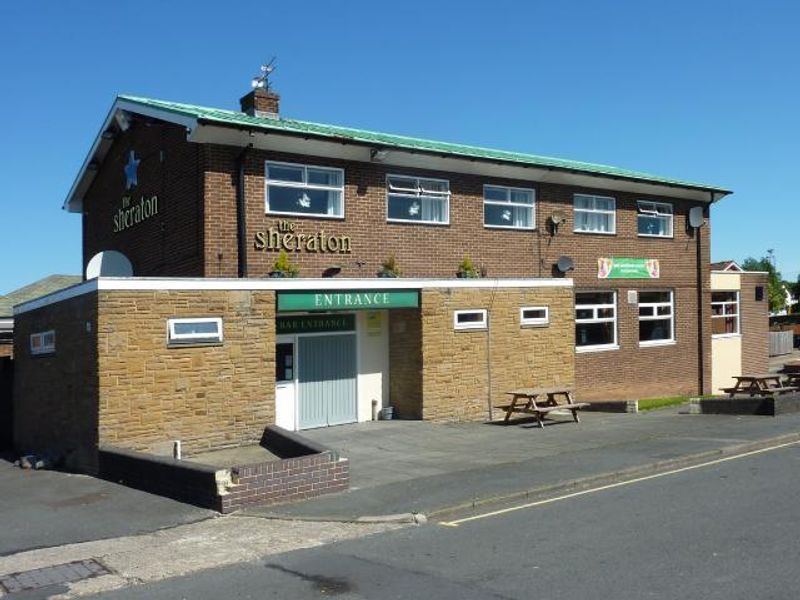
<box><xmin>421</xmin><ymin>288</ymin><xmax>575</xmax><ymax>421</ymax></box>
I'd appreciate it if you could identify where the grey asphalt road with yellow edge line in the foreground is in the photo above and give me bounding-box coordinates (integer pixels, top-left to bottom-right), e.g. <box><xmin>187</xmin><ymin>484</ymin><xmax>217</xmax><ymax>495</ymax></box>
<box><xmin>86</xmin><ymin>446</ymin><xmax>800</xmax><ymax>600</ymax></box>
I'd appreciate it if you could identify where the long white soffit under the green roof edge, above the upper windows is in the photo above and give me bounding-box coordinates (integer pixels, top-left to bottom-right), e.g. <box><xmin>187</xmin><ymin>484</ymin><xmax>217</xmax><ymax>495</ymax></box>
<box><xmin>192</xmin><ymin>123</ymin><xmax>725</xmax><ymax>203</ymax></box>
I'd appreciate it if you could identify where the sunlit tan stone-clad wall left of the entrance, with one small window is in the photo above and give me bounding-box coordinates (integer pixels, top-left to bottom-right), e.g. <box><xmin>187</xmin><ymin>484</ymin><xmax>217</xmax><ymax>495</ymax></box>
<box><xmin>97</xmin><ymin>291</ymin><xmax>275</xmax><ymax>455</ymax></box>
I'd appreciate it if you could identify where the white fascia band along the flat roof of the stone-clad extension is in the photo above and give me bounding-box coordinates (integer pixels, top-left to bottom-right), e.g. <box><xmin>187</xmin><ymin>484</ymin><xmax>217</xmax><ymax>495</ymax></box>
<box><xmin>14</xmin><ymin>277</ymin><xmax>573</xmax><ymax>315</ymax></box>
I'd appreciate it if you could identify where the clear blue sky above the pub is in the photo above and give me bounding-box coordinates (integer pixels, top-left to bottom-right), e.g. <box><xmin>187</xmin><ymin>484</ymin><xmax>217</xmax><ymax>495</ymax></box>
<box><xmin>0</xmin><ymin>0</ymin><xmax>800</xmax><ymax>293</ymax></box>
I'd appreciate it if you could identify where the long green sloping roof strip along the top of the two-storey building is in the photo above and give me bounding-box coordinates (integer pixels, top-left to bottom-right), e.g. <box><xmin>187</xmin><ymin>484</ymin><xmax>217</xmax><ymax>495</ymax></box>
<box><xmin>119</xmin><ymin>95</ymin><xmax>731</xmax><ymax>194</ymax></box>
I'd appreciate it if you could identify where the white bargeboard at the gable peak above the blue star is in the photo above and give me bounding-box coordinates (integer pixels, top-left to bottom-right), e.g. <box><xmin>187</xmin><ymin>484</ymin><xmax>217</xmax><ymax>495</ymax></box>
<box><xmin>62</xmin><ymin>98</ymin><xmax>197</xmax><ymax>213</ymax></box>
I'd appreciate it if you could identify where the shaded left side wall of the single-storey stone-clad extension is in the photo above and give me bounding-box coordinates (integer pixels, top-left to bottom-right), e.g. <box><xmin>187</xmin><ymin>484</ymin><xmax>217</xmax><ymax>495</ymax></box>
<box><xmin>14</xmin><ymin>293</ymin><xmax>98</xmax><ymax>471</ymax></box>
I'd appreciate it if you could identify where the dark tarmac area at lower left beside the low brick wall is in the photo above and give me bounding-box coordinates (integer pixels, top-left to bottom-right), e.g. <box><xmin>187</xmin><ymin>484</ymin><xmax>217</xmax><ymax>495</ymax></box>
<box><xmin>0</xmin><ymin>459</ymin><xmax>216</xmax><ymax>556</ymax></box>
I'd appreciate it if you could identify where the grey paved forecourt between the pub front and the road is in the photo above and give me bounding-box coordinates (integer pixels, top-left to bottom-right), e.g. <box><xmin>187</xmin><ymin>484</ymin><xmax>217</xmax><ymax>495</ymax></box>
<box><xmin>246</xmin><ymin>407</ymin><xmax>800</xmax><ymax>520</ymax></box>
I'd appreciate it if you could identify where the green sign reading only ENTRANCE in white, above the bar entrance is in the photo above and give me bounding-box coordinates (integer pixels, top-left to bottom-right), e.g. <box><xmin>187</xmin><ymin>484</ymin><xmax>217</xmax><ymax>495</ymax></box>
<box><xmin>278</xmin><ymin>290</ymin><xmax>419</xmax><ymax>312</ymax></box>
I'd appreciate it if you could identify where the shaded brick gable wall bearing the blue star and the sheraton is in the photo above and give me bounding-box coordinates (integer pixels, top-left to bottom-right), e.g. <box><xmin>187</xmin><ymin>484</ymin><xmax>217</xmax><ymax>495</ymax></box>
<box><xmin>83</xmin><ymin>119</ymin><xmax>204</xmax><ymax>277</ymax></box>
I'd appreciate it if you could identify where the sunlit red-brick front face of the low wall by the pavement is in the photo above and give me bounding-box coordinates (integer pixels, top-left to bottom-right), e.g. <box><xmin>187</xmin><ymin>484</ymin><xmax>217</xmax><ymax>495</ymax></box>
<box><xmin>225</xmin><ymin>450</ymin><xmax>350</xmax><ymax>513</ymax></box>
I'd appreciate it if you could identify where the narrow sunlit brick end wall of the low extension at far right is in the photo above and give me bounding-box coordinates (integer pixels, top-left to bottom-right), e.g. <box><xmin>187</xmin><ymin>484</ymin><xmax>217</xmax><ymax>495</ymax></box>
<box><xmin>739</xmin><ymin>273</ymin><xmax>769</xmax><ymax>373</ymax></box>
